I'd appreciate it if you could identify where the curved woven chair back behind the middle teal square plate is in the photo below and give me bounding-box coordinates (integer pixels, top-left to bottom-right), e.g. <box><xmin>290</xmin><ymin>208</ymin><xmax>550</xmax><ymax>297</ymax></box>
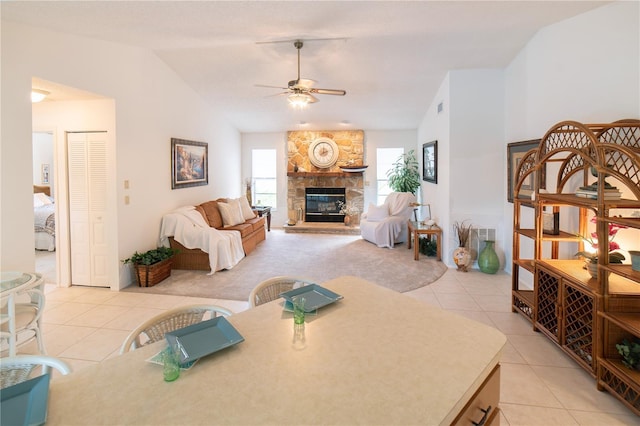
<box><xmin>120</xmin><ymin>305</ymin><xmax>232</xmax><ymax>354</ymax></box>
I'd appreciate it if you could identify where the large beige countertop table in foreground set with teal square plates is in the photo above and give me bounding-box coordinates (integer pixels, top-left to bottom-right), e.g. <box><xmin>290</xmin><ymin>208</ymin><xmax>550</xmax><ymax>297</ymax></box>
<box><xmin>47</xmin><ymin>277</ymin><xmax>506</xmax><ymax>425</ymax></box>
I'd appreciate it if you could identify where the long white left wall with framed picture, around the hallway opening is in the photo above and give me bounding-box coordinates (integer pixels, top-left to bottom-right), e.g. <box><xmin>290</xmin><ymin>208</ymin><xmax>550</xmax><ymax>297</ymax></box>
<box><xmin>0</xmin><ymin>21</ymin><xmax>241</xmax><ymax>287</ymax></box>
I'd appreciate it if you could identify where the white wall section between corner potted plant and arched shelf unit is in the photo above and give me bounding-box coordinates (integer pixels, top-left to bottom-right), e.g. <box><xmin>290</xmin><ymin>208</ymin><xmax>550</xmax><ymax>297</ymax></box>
<box><xmin>419</xmin><ymin>69</ymin><xmax>504</xmax><ymax>266</ymax></box>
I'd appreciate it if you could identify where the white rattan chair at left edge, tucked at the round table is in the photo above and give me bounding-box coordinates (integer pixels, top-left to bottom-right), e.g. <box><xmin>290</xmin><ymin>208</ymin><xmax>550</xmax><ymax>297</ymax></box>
<box><xmin>0</xmin><ymin>279</ymin><xmax>46</xmax><ymax>356</ymax></box>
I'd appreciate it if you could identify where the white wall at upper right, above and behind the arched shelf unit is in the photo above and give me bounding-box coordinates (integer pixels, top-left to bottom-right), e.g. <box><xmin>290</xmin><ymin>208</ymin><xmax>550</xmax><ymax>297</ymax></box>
<box><xmin>503</xmin><ymin>2</ymin><xmax>640</xmax><ymax>271</ymax></box>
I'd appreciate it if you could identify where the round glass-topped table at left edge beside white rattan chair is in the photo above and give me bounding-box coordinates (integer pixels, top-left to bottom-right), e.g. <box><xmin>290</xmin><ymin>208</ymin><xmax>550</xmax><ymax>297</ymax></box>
<box><xmin>0</xmin><ymin>272</ymin><xmax>43</xmax><ymax>356</ymax></box>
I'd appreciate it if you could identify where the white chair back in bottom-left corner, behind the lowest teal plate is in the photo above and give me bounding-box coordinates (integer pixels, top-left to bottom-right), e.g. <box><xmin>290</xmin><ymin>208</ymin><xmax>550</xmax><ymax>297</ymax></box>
<box><xmin>0</xmin><ymin>355</ymin><xmax>71</xmax><ymax>389</ymax></box>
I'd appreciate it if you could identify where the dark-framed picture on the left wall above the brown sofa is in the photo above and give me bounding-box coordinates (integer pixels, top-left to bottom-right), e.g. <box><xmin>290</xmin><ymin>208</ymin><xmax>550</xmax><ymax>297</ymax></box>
<box><xmin>171</xmin><ymin>138</ymin><xmax>209</xmax><ymax>189</ymax></box>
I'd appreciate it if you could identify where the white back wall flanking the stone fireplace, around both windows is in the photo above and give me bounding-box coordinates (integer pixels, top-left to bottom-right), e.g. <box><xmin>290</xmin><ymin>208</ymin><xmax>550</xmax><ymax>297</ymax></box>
<box><xmin>242</xmin><ymin>130</ymin><xmax>421</xmax><ymax>228</ymax></box>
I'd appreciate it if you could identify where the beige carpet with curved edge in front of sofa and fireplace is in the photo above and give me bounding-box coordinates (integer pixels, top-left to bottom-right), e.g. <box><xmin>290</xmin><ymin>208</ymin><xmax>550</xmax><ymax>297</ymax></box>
<box><xmin>124</xmin><ymin>229</ymin><xmax>447</xmax><ymax>300</ymax></box>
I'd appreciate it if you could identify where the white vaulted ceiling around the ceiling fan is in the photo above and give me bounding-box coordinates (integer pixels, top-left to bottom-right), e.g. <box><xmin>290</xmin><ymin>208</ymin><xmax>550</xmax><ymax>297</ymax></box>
<box><xmin>0</xmin><ymin>1</ymin><xmax>608</xmax><ymax>132</ymax></box>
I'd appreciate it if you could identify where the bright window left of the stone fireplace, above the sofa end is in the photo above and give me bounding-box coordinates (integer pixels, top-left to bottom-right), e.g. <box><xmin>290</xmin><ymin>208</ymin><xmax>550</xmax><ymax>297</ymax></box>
<box><xmin>251</xmin><ymin>149</ymin><xmax>278</xmax><ymax>207</ymax></box>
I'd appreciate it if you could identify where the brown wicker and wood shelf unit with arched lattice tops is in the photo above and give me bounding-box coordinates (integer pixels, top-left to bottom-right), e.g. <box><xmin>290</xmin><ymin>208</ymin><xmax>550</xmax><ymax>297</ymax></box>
<box><xmin>512</xmin><ymin>120</ymin><xmax>640</xmax><ymax>416</ymax></box>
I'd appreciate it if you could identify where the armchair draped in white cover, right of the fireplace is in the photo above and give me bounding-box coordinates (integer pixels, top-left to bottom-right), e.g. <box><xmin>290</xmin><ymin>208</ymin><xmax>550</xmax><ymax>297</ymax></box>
<box><xmin>360</xmin><ymin>192</ymin><xmax>416</xmax><ymax>248</ymax></box>
